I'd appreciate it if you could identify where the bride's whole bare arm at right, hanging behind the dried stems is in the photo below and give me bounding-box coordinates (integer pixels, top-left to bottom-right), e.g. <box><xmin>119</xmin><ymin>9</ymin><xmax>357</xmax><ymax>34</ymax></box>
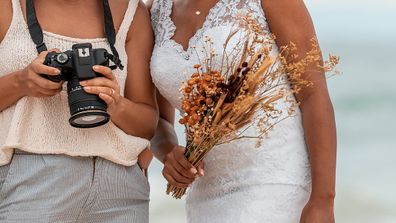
<box><xmin>262</xmin><ymin>0</ymin><xmax>337</xmax><ymax>222</ymax></box>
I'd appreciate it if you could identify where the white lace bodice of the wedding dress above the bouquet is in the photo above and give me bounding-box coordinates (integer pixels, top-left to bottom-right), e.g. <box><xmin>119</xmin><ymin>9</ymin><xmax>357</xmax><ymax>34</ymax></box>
<box><xmin>151</xmin><ymin>0</ymin><xmax>267</xmax><ymax>108</ymax></box>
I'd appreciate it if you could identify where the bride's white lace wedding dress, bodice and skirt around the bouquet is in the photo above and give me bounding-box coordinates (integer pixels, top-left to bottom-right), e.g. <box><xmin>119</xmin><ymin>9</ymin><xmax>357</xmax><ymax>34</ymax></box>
<box><xmin>151</xmin><ymin>0</ymin><xmax>311</xmax><ymax>223</ymax></box>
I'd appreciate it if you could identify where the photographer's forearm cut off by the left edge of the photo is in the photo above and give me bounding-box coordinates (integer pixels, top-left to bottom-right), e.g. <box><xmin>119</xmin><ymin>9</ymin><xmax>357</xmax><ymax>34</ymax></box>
<box><xmin>0</xmin><ymin>71</ymin><xmax>24</xmax><ymax>111</ymax></box>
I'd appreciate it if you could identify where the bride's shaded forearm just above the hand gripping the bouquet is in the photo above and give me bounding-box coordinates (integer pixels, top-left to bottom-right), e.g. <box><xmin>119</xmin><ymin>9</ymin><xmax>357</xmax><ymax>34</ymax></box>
<box><xmin>151</xmin><ymin>118</ymin><xmax>179</xmax><ymax>162</ymax></box>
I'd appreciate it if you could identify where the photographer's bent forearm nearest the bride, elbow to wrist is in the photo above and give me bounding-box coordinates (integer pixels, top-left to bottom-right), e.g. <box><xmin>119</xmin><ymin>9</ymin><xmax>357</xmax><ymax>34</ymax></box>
<box><xmin>111</xmin><ymin>97</ymin><xmax>158</xmax><ymax>140</ymax></box>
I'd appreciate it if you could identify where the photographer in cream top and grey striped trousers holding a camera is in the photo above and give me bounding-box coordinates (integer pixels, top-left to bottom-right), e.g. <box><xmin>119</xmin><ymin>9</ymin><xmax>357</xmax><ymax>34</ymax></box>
<box><xmin>0</xmin><ymin>0</ymin><xmax>158</xmax><ymax>223</ymax></box>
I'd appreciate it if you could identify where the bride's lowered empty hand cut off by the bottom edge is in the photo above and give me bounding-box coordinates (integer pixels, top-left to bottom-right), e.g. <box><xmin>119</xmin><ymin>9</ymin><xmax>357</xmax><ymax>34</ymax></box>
<box><xmin>300</xmin><ymin>199</ymin><xmax>335</xmax><ymax>223</ymax></box>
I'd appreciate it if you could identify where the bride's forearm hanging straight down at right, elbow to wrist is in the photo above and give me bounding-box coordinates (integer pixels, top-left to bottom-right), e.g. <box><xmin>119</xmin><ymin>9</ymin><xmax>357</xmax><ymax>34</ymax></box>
<box><xmin>301</xmin><ymin>92</ymin><xmax>337</xmax><ymax>201</ymax></box>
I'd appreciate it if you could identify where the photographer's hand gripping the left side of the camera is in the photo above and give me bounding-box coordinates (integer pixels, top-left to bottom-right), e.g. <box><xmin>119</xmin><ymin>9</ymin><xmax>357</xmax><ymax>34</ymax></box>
<box><xmin>17</xmin><ymin>51</ymin><xmax>63</xmax><ymax>98</ymax></box>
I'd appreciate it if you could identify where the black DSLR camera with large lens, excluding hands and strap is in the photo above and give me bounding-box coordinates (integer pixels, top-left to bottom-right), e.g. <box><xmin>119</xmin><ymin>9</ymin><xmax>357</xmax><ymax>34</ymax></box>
<box><xmin>43</xmin><ymin>43</ymin><xmax>110</xmax><ymax>128</ymax></box>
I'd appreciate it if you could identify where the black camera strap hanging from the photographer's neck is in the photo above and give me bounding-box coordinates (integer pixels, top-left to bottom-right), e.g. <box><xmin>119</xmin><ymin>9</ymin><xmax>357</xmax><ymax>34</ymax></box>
<box><xmin>26</xmin><ymin>0</ymin><xmax>124</xmax><ymax>70</ymax></box>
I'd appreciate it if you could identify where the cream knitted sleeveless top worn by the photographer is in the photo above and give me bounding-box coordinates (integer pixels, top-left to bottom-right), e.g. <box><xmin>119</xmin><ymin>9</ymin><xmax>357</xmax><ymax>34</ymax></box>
<box><xmin>0</xmin><ymin>0</ymin><xmax>149</xmax><ymax>166</ymax></box>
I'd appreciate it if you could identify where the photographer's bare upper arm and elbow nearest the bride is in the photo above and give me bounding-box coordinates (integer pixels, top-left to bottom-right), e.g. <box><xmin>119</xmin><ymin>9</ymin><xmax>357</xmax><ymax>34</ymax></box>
<box><xmin>118</xmin><ymin>2</ymin><xmax>158</xmax><ymax>139</ymax></box>
